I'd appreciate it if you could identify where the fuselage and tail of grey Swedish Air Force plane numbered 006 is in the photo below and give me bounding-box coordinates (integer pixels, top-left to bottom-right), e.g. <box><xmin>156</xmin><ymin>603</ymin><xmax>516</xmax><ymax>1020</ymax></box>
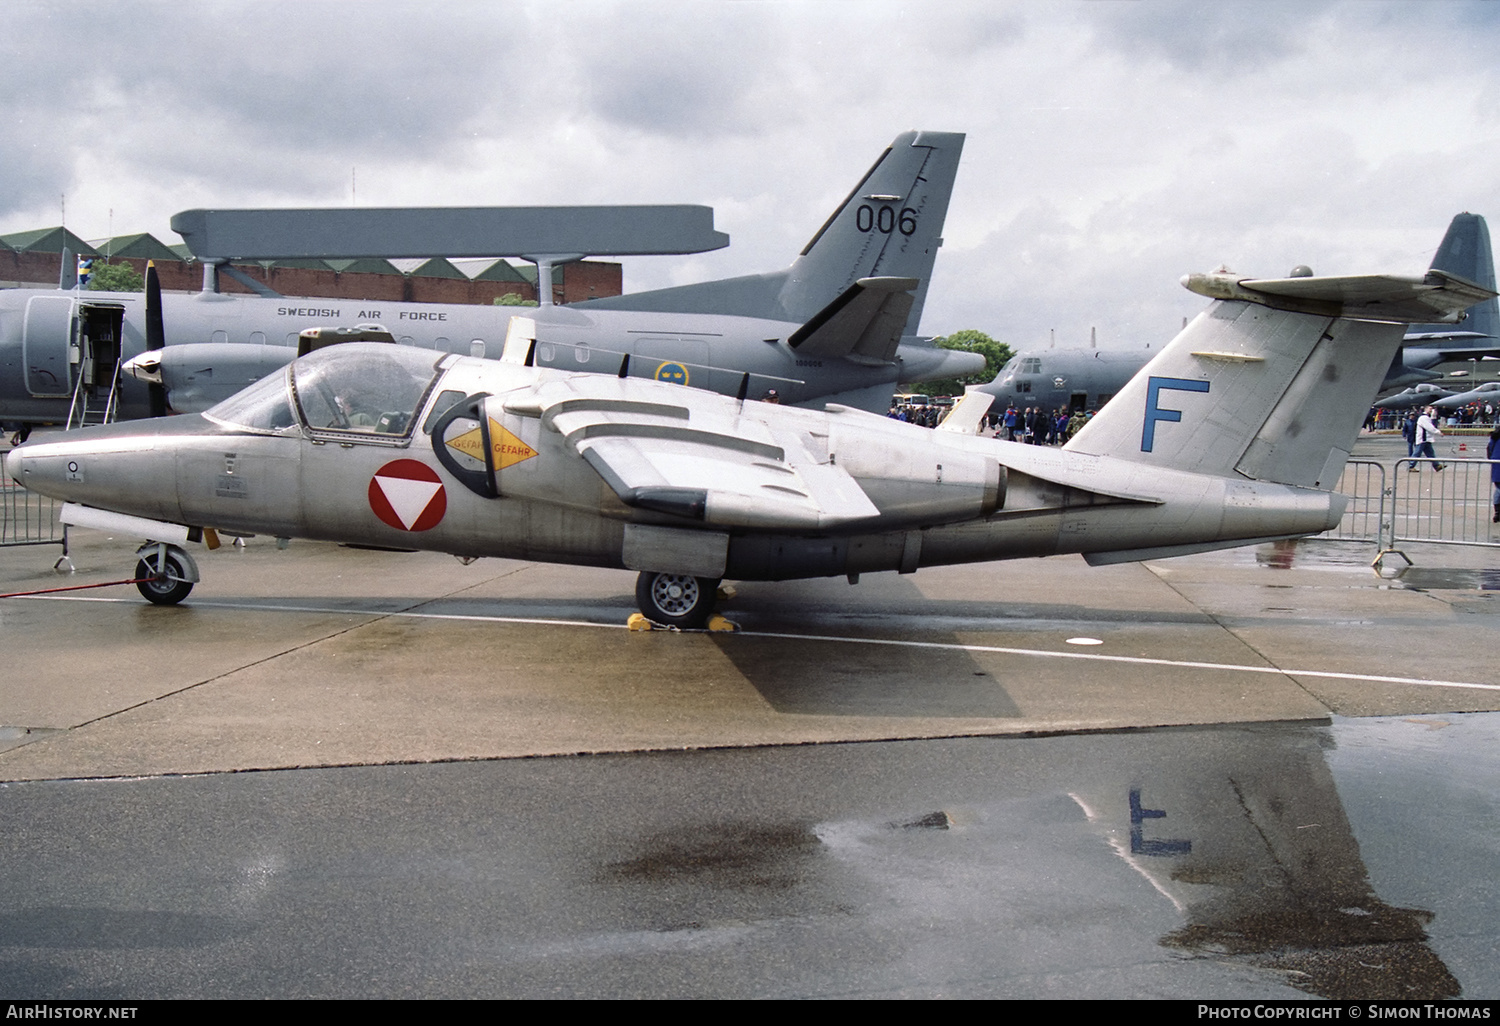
<box><xmin>0</xmin><ymin>132</ymin><xmax>983</xmax><ymax>429</ymax></box>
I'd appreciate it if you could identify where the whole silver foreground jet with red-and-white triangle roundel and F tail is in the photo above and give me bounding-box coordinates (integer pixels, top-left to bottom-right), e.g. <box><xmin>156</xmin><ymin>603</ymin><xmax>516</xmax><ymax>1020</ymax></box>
<box><xmin>6</xmin><ymin>255</ymin><xmax>1494</xmax><ymax>627</ymax></box>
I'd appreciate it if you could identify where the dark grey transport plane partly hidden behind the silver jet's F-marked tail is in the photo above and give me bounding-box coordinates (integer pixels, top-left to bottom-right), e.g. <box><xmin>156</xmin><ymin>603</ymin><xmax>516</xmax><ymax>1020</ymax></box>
<box><xmin>977</xmin><ymin>213</ymin><xmax>1500</xmax><ymax>411</ymax></box>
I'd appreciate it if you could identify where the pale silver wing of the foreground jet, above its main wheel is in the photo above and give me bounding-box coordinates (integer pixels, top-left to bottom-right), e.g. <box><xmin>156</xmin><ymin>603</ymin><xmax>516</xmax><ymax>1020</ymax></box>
<box><xmin>507</xmin><ymin>378</ymin><xmax>879</xmax><ymax>530</ymax></box>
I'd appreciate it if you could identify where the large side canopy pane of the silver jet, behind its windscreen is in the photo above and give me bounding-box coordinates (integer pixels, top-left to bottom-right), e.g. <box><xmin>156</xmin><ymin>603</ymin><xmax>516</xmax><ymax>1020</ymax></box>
<box><xmin>291</xmin><ymin>344</ymin><xmax>438</xmax><ymax>441</ymax></box>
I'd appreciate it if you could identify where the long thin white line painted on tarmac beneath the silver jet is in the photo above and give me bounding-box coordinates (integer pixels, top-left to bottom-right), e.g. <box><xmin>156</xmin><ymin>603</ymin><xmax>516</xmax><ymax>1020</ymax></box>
<box><xmin>11</xmin><ymin>596</ymin><xmax>1500</xmax><ymax>692</ymax></box>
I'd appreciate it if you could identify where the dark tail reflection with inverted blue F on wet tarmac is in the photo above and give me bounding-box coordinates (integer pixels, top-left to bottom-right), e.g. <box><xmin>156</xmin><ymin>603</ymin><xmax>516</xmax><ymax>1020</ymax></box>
<box><xmin>1122</xmin><ymin>731</ymin><xmax>1461</xmax><ymax>999</ymax></box>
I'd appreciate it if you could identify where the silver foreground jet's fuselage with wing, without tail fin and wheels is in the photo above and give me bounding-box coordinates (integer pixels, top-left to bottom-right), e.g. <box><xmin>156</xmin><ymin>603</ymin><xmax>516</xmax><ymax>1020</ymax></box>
<box><xmin>6</xmin><ymin>345</ymin><xmax>1344</xmax><ymax>581</ymax></box>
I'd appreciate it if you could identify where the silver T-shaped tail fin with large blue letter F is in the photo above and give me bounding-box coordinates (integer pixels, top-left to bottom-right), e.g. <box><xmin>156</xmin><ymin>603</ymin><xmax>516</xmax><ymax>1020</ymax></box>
<box><xmin>1067</xmin><ymin>270</ymin><xmax>1496</xmax><ymax>489</ymax></box>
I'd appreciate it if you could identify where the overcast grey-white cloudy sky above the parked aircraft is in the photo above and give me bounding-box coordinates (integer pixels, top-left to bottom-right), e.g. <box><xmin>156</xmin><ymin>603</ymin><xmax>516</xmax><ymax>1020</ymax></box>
<box><xmin>0</xmin><ymin>0</ymin><xmax>1500</xmax><ymax>347</ymax></box>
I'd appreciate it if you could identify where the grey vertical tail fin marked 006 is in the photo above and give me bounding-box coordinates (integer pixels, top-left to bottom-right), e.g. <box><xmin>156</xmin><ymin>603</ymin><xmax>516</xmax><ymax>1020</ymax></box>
<box><xmin>578</xmin><ymin>132</ymin><xmax>963</xmax><ymax>335</ymax></box>
